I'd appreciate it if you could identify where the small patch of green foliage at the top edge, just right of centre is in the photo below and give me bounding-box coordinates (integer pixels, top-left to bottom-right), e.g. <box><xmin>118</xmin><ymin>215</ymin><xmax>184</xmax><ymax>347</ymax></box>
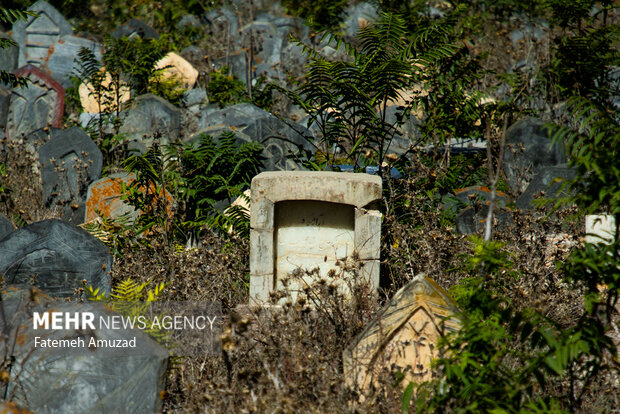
<box><xmin>282</xmin><ymin>0</ymin><xmax>347</xmax><ymax>30</ymax></box>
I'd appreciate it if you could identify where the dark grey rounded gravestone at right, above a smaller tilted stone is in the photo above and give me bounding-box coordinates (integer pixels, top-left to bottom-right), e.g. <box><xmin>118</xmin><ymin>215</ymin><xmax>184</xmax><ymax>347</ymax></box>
<box><xmin>503</xmin><ymin>118</ymin><xmax>566</xmax><ymax>195</ymax></box>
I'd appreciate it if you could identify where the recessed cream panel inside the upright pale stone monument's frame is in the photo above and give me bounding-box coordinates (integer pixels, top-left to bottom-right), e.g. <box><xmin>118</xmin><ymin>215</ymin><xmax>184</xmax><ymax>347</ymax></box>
<box><xmin>274</xmin><ymin>200</ymin><xmax>355</xmax><ymax>299</ymax></box>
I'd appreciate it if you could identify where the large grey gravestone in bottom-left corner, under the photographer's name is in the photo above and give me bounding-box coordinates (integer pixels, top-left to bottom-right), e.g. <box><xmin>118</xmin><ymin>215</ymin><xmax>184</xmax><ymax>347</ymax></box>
<box><xmin>0</xmin><ymin>291</ymin><xmax>168</xmax><ymax>414</ymax></box>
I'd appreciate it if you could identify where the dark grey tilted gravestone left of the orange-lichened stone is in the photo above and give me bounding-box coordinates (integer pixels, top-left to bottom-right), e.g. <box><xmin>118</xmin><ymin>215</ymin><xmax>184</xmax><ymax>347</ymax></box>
<box><xmin>39</xmin><ymin>127</ymin><xmax>103</xmax><ymax>224</ymax></box>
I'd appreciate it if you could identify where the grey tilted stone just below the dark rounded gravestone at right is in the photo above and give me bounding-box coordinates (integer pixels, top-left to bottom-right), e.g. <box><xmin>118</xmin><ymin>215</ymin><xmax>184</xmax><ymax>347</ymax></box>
<box><xmin>517</xmin><ymin>164</ymin><xmax>576</xmax><ymax>210</ymax></box>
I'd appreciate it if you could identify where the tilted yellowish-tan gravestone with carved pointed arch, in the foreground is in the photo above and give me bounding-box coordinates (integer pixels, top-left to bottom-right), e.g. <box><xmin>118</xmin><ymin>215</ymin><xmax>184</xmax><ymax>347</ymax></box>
<box><xmin>342</xmin><ymin>274</ymin><xmax>459</xmax><ymax>391</ymax></box>
